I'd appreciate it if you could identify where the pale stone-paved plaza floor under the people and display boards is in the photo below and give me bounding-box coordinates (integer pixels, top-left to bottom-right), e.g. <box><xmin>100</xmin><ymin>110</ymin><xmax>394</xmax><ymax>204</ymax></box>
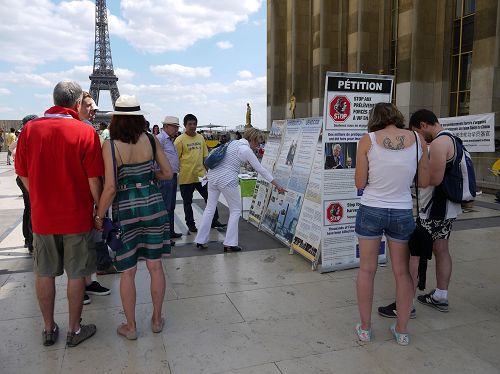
<box><xmin>0</xmin><ymin>153</ymin><xmax>500</xmax><ymax>374</ymax></box>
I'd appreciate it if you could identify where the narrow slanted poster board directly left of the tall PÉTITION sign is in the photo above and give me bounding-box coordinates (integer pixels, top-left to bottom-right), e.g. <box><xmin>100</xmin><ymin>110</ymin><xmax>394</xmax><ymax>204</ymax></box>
<box><xmin>291</xmin><ymin>139</ymin><xmax>323</xmax><ymax>261</ymax></box>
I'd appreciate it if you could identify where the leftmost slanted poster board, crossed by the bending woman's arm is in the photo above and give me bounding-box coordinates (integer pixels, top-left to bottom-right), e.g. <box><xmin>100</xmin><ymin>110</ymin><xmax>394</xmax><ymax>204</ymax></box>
<box><xmin>248</xmin><ymin>120</ymin><xmax>286</xmax><ymax>226</ymax></box>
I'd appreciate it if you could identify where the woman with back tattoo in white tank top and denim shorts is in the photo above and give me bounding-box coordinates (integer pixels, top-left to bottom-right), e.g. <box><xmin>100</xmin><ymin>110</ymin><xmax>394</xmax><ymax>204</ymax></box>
<box><xmin>355</xmin><ymin>103</ymin><xmax>429</xmax><ymax>345</ymax></box>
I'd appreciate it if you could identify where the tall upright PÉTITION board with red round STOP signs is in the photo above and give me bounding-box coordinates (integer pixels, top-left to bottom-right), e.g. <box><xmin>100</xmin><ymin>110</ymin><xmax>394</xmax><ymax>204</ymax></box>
<box><xmin>321</xmin><ymin>73</ymin><xmax>393</xmax><ymax>272</ymax></box>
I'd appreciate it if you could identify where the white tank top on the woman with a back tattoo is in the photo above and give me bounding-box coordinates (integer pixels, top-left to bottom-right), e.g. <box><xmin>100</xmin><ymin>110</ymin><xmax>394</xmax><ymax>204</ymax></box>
<box><xmin>361</xmin><ymin>131</ymin><xmax>422</xmax><ymax>209</ymax></box>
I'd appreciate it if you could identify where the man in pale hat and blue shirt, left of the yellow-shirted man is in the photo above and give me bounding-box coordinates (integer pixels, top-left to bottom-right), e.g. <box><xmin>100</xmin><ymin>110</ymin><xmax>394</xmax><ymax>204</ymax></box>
<box><xmin>156</xmin><ymin>116</ymin><xmax>182</xmax><ymax>240</ymax></box>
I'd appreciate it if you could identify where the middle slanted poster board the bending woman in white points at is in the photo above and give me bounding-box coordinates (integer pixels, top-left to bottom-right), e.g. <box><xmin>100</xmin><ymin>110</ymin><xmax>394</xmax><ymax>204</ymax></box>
<box><xmin>261</xmin><ymin>118</ymin><xmax>322</xmax><ymax>245</ymax></box>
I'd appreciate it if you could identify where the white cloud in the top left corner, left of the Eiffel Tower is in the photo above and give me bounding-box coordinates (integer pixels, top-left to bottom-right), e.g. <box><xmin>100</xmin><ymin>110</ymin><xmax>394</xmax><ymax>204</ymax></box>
<box><xmin>0</xmin><ymin>0</ymin><xmax>95</xmax><ymax>65</ymax></box>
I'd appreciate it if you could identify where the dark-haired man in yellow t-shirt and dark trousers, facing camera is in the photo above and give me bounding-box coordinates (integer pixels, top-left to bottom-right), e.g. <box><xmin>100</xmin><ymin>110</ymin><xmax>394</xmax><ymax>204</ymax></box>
<box><xmin>174</xmin><ymin>114</ymin><xmax>226</xmax><ymax>232</ymax></box>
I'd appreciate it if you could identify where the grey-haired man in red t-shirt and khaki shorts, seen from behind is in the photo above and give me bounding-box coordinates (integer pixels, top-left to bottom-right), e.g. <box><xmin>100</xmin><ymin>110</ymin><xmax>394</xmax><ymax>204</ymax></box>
<box><xmin>15</xmin><ymin>81</ymin><xmax>104</xmax><ymax>347</ymax></box>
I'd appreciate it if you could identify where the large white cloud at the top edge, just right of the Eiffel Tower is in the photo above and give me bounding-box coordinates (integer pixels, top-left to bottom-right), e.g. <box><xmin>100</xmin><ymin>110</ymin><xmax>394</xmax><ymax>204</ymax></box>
<box><xmin>108</xmin><ymin>0</ymin><xmax>263</xmax><ymax>53</ymax></box>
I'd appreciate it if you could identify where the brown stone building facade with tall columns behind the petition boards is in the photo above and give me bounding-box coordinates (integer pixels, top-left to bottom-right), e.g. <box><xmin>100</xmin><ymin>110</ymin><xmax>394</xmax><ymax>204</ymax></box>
<box><xmin>267</xmin><ymin>0</ymin><xmax>500</xmax><ymax>188</ymax></box>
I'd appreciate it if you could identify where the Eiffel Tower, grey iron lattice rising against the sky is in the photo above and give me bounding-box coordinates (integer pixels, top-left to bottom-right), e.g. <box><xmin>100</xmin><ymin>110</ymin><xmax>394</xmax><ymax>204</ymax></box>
<box><xmin>89</xmin><ymin>0</ymin><xmax>120</xmax><ymax>108</ymax></box>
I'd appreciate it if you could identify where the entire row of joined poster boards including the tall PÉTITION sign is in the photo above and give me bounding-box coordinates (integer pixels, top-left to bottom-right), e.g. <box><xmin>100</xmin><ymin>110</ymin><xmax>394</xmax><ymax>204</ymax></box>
<box><xmin>249</xmin><ymin>73</ymin><xmax>393</xmax><ymax>272</ymax></box>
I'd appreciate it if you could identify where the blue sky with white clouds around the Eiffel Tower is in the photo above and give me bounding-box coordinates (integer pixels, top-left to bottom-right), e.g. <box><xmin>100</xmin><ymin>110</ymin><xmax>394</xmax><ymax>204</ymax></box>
<box><xmin>0</xmin><ymin>0</ymin><xmax>266</xmax><ymax>128</ymax></box>
